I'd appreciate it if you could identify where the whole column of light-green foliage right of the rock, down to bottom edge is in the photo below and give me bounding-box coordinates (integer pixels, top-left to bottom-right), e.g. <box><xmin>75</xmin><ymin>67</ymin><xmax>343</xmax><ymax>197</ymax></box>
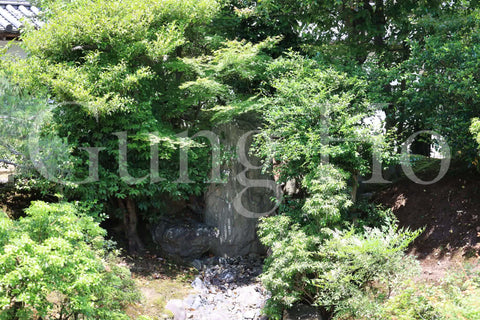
<box><xmin>248</xmin><ymin>52</ymin><xmax>408</xmax><ymax>317</ymax></box>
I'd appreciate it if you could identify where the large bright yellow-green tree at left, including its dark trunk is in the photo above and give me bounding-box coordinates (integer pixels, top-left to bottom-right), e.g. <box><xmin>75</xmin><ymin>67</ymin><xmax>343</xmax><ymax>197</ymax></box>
<box><xmin>4</xmin><ymin>0</ymin><xmax>218</xmax><ymax>251</ymax></box>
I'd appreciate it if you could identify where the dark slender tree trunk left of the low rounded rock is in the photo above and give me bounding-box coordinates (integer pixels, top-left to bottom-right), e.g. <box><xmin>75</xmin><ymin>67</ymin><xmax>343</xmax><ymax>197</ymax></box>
<box><xmin>118</xmin><ymin>198</ymin><xmax>144</xmax><ymax>254</ymax></box>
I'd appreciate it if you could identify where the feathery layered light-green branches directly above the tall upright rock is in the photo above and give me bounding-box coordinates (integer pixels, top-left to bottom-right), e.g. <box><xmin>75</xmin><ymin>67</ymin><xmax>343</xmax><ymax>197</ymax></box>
<box><xmin>180</xmin><ymin>37</ymin><xmax>280</xmax><ymax>123</ymax></box>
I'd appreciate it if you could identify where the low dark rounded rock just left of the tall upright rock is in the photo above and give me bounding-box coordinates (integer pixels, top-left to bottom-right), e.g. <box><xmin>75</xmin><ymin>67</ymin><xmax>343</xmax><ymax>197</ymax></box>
<box><xmin>152</xmin><ymin>221</ymin><xmax>218</xmax><ymax>260</ymax></box>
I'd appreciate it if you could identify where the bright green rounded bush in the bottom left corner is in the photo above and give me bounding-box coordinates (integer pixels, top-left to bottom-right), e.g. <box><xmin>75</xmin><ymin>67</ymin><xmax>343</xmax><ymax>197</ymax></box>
<box><xmin>0</xmin><ymin>202</ymin><xmax>139</xmax><ymax>319</ymax></box>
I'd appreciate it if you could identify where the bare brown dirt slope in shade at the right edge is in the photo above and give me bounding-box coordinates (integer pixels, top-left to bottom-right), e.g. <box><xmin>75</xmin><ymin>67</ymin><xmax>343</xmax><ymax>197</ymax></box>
<box><xmin>375</xmin><ymin>172</ymin><xmax>480</xmax><ymax>280</ymax></box>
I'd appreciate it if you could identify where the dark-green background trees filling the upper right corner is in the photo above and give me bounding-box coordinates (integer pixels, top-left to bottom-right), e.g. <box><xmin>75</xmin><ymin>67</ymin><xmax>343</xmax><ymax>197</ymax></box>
<box><xmin>225</xmin><ymin>0</ymin><xmax>478</xmax><ymax>162</ymax></box>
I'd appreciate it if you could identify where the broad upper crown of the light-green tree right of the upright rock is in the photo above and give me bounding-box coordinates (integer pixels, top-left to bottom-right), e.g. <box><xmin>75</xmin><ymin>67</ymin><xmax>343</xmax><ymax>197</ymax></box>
<box><xmin>258</xmin><ymin>53</ymin><xmax>385</xmax><ymax>182</ymax></box>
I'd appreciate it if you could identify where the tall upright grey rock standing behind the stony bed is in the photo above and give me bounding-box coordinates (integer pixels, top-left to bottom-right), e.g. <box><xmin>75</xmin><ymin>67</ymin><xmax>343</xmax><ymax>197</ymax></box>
<box><xmin>205</xmin><ymin>122</ymin><xmax>274</xmax><ymax>256</ymax></box>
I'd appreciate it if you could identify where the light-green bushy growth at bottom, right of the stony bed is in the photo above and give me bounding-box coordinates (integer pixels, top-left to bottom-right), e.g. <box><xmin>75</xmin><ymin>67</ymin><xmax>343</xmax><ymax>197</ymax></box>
<box><xmin>260</xmin><ymin>216</ymin><xmax>419</xmax><ymax>319</ymax></box>
